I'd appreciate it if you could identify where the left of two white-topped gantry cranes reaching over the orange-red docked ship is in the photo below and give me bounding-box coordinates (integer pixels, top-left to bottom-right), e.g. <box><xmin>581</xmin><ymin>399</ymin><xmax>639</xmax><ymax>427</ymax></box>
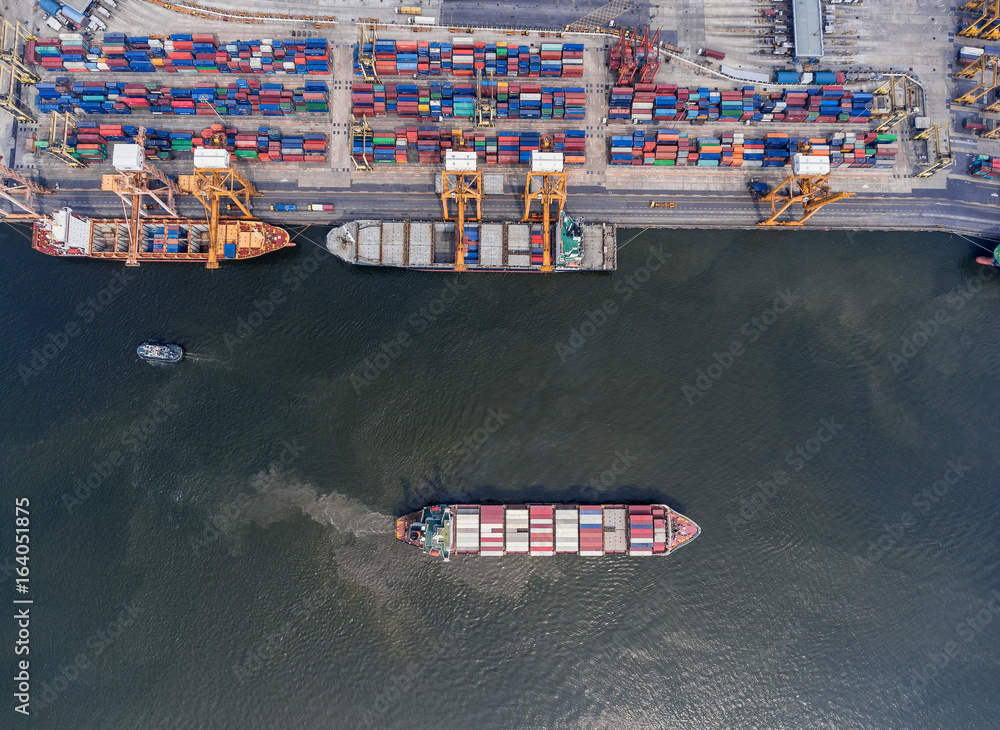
<box><xmin>101</xmin><ymin>127</ymin><xmax>180</xmax><ymax>266</ymax></box>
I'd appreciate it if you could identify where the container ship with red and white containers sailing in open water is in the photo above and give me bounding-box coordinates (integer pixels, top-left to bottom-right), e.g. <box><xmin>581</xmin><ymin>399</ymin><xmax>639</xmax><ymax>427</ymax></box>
<box><xmin>396</xmin><ymin>504</ymin><xmax>701</xmax><ymax>560</ymax></box>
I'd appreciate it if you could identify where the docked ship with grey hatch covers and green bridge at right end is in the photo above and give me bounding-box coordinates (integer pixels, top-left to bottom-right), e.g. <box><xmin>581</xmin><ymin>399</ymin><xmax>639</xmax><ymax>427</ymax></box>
<box><xmin>326</xmin><ymin>219</ymin><xmax>618</xmax><ymax>272</ymax></box>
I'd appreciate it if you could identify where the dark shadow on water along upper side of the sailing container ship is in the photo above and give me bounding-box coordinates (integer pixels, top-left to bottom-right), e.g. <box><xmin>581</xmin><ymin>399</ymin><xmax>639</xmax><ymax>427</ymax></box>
<box><xmin>393</xmin><ymin>479</ymin><xmax>687</xmax><ymax>517</ymax></box>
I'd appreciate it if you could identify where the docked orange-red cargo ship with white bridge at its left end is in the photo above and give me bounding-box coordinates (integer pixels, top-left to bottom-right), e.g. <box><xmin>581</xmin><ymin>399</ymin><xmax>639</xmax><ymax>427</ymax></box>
<box><xmin>31</xmin><ymin>208</ymin><xmax>295</xmax><ymax>263</ymax></box>
